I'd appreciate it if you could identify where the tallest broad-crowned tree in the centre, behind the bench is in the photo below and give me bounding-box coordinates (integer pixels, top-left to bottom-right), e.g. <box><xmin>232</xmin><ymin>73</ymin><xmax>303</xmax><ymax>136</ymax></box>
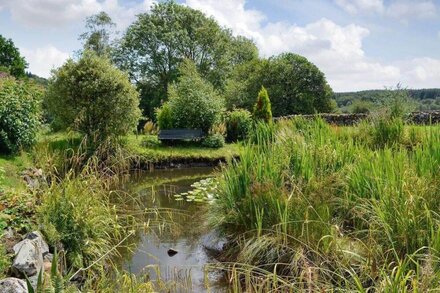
<box><xmin>113</xmin><ymin>1</ymin><xmax>258</xmax><ymax>117</ymax></box>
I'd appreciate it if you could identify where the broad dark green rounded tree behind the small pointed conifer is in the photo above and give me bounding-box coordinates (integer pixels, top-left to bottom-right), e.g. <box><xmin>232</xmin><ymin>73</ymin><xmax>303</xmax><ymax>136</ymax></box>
<box><xmin>225</xmin><ymin>53</ymin><xmax>332</xmax><ymax>116</ymax></box>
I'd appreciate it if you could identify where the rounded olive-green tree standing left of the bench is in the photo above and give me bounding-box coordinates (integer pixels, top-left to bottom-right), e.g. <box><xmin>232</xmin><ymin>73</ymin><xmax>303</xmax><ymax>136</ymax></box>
<box><xmin>46</xmin><ymin>51</ymin><xmax>140</xmax><ymax>141</ymax></box>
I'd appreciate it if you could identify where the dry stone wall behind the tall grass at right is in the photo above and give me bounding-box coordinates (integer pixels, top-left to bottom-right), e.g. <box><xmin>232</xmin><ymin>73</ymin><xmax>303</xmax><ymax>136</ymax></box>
<box><xmin>274</xmin><ymin>111</ymin><xmax>440</xmax><ymax>126</ymax></box>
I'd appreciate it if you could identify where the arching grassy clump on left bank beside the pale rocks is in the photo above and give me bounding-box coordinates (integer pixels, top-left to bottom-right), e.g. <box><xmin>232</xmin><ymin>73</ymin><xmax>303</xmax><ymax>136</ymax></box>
<box><xmin>37</xmin><ymin>174</ymin><xmax>121</xmax><ymax>269</ymax></box>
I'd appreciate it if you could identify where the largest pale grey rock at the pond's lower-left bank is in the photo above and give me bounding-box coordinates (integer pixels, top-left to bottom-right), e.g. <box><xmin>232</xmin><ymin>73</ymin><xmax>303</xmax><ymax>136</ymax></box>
<box><xmin>12</xmin><ymin>231</ymin><xmax>49</xmax><ymax>277</ymax></box>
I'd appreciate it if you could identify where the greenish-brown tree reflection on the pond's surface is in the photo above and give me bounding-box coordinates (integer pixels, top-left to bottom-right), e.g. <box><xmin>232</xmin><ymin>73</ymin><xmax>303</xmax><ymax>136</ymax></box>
<box><xmin>114</xmin><ymin>168</ymin><xmax>212</xmax><ymax>274</ymax></box>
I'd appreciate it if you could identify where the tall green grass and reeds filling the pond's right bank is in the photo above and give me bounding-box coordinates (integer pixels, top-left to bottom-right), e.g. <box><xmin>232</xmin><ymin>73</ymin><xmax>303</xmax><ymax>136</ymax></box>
<box><xmin>213</xmin><ymin>118</ymin><xmax>440</xmax><ymax>292</ymax></box>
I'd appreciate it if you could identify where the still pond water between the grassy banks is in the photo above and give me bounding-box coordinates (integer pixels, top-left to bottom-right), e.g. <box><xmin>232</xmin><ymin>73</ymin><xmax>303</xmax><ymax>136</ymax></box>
<box><xmin>117</xmin><ymin>168</ymin><xmax>226</xmax><ymax>292</ymax></box>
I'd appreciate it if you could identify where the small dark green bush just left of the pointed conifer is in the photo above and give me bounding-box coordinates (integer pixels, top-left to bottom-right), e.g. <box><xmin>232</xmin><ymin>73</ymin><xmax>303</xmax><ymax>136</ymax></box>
<box><xmin>226</xmin><ymin>109</ymin><xmax>252</xmax><ymax>142</ymax></box>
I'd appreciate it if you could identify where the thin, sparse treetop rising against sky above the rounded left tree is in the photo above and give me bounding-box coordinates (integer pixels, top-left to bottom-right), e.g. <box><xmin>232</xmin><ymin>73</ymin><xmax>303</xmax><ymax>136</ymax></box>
<box><xmin>79</xmin><ymin>11</ymin><xmax>116</xmax><ymax>57</ymax></box>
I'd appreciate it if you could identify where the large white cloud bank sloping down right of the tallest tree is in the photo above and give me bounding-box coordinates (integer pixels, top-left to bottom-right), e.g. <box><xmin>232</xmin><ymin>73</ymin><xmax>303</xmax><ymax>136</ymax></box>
<box><xmin>186</xmin><ymin>0</ymin><xmax>440</xmax><ymax>91</ymax></box>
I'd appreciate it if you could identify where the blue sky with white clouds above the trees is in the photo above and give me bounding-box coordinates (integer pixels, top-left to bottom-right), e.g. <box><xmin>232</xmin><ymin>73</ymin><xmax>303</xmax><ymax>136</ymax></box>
<box><xmin>0</xmin><ymin>0</ymin><xmax>440</xmax><ymax>92</ymax></box>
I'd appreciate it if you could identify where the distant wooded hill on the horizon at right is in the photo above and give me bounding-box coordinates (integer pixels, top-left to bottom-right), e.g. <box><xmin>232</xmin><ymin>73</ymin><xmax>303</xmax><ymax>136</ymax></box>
<box><xmin>334</xmin><ymin>88</ymin><xmax>440</xmax><ymax>113</ymax></box>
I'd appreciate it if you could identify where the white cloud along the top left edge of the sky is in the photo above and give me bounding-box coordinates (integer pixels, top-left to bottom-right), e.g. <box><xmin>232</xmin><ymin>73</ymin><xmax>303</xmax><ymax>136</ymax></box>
<box><xmin>0</xmin><ymin>0</ymin><xmax>155</xmax><ymax>28</ymax></box>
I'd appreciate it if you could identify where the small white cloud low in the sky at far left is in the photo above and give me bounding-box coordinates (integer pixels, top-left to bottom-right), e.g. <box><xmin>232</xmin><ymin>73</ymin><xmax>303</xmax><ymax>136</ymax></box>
<box><xmin>20</xmin><ymin>45</ymin><xmax>69</xmax><ymax>77</ymax></box>
